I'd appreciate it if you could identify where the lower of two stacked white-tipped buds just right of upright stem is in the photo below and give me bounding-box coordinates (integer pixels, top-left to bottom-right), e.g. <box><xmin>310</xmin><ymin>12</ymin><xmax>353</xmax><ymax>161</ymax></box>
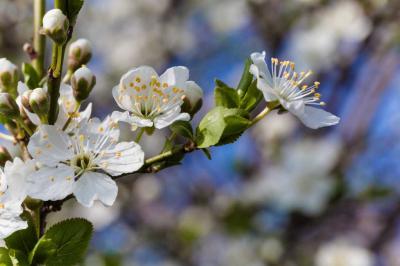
<box><xmin>71</xmin><ymin>66</ymin><xmax>96</xmax><ymax>102</ymax></box>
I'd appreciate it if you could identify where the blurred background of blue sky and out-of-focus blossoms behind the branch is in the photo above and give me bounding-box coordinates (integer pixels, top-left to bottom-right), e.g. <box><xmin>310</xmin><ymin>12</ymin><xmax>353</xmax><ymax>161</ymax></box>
<box><xmin>0</xmin><ymin>0</ymin><xmax>400</xmax><ymax>266</ymax></box>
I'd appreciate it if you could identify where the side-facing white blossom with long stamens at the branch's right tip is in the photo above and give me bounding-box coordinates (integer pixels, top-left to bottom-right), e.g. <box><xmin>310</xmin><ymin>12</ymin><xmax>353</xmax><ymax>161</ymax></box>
<box><xmin>250</xmin><ymin>52</ymin><xmax>340</xmax><ymax>129</ymax></box>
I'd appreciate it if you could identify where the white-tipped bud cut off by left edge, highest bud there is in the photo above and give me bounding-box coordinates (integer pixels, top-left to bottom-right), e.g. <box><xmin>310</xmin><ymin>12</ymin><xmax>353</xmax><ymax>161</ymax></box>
<box><xmin>0</xmin><ymin>58</ymin><xmax>18</xmax><ymax>96</ymax></box>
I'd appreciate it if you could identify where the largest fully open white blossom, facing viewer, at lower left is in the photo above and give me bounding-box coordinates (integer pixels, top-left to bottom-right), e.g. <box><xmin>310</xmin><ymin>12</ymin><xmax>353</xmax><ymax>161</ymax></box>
<box><xmin>28</xmin><ymin>117</ymin><xmax>144</xmax><ymax>207</ymax></box>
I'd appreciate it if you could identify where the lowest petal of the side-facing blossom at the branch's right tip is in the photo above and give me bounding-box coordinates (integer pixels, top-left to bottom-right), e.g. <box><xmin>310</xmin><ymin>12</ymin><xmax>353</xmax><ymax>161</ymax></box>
<box><xmin>295</xmin><ymin>106</ymin><xmax>340</xmax><ymax>129</ymax></box>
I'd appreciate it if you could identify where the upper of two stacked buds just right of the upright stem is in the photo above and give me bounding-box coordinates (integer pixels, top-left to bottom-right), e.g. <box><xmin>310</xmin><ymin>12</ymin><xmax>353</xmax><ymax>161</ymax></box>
<box><xmin>68</xmin><ymin>39</ymin><xmax>92</xmax><ymax>71</ymax></box>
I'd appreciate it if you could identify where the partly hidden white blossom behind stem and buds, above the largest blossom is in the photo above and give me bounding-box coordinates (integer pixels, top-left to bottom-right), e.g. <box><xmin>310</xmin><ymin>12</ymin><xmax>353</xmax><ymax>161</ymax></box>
<box><xmin>17</xmin><ymin>82</ymin><xmax>92</xmax><ymax>131</ymax></box>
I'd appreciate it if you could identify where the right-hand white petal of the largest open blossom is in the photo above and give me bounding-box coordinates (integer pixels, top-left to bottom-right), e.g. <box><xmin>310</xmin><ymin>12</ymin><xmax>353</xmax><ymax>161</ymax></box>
<box><xmin>96</xmin><ymin>142</ymin><xmax>144</xmax><ymax>176</ymax></box>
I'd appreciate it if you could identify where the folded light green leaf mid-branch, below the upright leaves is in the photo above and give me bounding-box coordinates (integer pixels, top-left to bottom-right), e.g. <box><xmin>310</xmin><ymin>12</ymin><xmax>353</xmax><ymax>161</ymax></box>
<box><xmin>196</xmin><ymin>106</ymin><xmax>250</xmax><ymax>148</ymax></box>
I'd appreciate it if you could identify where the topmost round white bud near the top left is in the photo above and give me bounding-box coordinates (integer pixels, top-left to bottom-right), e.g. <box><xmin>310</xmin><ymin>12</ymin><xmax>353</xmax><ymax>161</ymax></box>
<box><xmin>43</xmin><ymin>9</ymin><xmax>69</xmax><ymax>44</ymax></box>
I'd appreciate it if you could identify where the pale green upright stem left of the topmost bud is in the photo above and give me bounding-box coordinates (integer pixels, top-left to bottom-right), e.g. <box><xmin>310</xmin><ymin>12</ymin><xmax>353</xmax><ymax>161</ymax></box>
<box><xmin>32</xmin><ymin>0</ymin><xmax>46</xmax><ymax>77</ymax></box>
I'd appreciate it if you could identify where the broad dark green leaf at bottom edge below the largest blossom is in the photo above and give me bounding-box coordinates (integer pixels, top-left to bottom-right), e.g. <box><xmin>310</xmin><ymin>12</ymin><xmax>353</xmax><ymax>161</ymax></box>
<box><xmin>30</xmin><ymin>218</ymin><xmax>93</xmax><ymax>266</ymax></box>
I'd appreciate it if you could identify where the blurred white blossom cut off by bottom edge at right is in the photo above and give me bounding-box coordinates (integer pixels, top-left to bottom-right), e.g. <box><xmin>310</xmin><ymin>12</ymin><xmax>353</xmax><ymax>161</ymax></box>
<box><xmin>315</xmin><ymin>239</ymin><xmax>374</xmax><ymax>266</ymax></box>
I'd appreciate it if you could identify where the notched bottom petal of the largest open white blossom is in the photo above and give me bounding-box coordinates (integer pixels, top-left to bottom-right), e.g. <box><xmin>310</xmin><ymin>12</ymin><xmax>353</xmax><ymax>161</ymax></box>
<box><xmin>74</xmin><ymin>172</ymin><xmax>118</xmax><ymax>207</ymax></box>
